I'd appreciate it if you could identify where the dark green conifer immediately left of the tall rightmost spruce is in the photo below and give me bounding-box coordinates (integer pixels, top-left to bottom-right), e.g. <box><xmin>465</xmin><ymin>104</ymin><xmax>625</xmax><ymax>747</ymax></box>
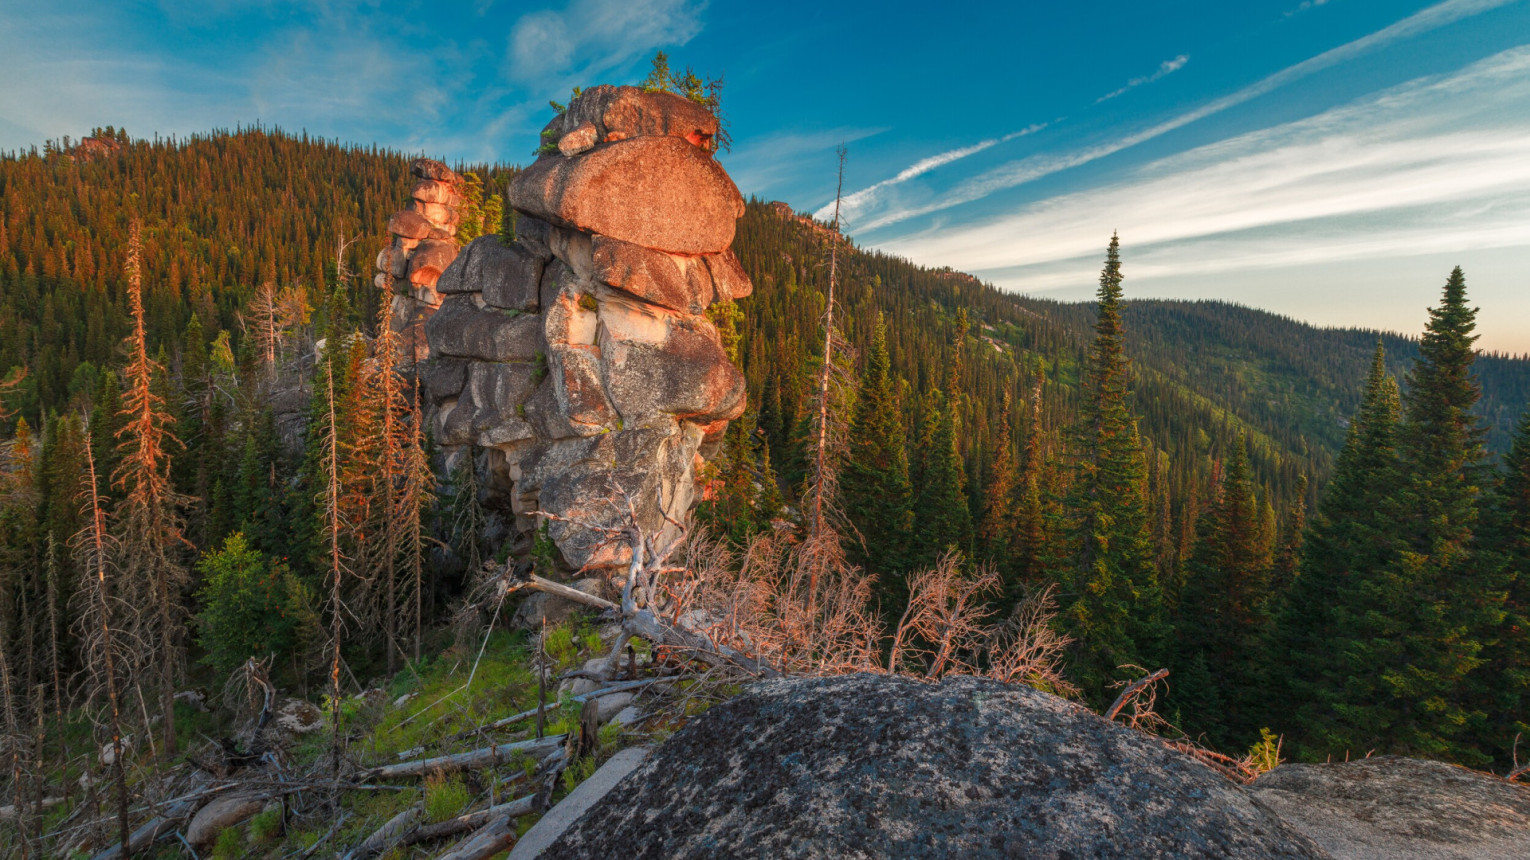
<box><xmin>1264</xmin><ymin>341</ymin><xmax>1400</xmax><ymax>757</ymax></box>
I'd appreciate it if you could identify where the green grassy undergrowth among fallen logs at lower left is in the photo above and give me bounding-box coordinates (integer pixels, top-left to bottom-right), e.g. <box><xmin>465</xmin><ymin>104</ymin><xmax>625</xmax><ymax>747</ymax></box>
<box><xmin>25</xmin><ymin>617</ymin><xmax>669</xmax><ymax>860</ymax></box>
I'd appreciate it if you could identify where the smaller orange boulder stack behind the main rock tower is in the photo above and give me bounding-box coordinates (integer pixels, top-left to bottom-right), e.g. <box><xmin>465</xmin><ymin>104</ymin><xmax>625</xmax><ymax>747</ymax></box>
<box><xmin>373</xmin><ymin>158</ymin><xmax>462</xmax><ymax>361</ymax></box>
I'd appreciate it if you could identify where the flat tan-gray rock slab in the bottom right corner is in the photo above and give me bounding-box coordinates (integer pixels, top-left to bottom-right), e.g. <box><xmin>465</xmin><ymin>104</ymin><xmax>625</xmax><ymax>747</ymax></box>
<box><xmin>1248</xmin><ymin>756</ymin><xmax>1530</xmax><ymax>860</ymax></box>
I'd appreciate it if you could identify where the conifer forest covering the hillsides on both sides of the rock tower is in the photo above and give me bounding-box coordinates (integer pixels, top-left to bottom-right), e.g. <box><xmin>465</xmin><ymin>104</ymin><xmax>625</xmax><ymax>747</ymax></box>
<box><xmin>0</xmin><ymin>120</ymin><xmax>1530</xmax><ymax>857</ymax></box>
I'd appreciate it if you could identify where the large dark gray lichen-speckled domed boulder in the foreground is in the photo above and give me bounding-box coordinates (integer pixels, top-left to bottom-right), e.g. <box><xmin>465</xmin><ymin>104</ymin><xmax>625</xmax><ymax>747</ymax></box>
<box><xmin>542</xmin><ymin>675</ymin><xmax>1328</xmax><ymax>860</ymax></box>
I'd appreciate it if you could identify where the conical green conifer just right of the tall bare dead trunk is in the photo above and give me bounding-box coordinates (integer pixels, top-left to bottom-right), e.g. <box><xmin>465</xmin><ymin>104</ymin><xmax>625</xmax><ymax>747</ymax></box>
<box><xmin>840</xmin><ymin>314</ymin><xmax>912</xmax><ymax>583</ymax></box>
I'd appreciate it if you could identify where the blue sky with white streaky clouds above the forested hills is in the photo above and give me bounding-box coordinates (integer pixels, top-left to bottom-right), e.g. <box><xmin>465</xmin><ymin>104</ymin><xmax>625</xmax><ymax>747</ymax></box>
<box><xmin>0</xmin><ymin>0</ymin><xmax>1530</xmax><ymax>353</ymax></box>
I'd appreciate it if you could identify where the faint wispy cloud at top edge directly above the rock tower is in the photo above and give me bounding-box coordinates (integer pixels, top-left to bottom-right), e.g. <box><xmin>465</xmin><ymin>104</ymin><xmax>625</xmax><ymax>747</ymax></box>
<box><xmin>509</xmin><ymin>0</ymin><xmax>707</xmax><ymax>87</ymax></box>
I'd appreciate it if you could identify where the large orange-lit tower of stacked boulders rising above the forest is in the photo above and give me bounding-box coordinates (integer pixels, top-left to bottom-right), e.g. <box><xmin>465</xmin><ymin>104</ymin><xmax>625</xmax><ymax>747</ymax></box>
<box><xmin>419</xmin><ymin>86</ymin><xmax>753</xmax><ymax>569</ymax></box>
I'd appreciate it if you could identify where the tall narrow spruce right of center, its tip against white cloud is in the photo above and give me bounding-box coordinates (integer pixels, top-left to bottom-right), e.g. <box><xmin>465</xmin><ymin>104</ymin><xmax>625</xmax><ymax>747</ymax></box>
<box><xmin>1062</xmin><ymin>236</ymin><xmax>1163</xmax><ymax>699</ymax></box>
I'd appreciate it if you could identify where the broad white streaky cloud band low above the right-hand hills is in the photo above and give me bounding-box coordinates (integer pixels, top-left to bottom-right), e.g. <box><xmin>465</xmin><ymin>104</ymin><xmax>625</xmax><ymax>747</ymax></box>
<box><xmin>887</xmin><ymin>47</ymin><xmax>1530</xmax><ymax>289</ymax></box>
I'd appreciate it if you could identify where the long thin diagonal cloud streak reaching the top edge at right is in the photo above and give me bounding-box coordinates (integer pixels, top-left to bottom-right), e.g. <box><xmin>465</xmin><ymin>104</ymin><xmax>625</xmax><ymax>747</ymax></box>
<box><xmin>860</xmin><ymin>0</ymin><xmax>1516</xmax><ymax>231</ymax></box>
